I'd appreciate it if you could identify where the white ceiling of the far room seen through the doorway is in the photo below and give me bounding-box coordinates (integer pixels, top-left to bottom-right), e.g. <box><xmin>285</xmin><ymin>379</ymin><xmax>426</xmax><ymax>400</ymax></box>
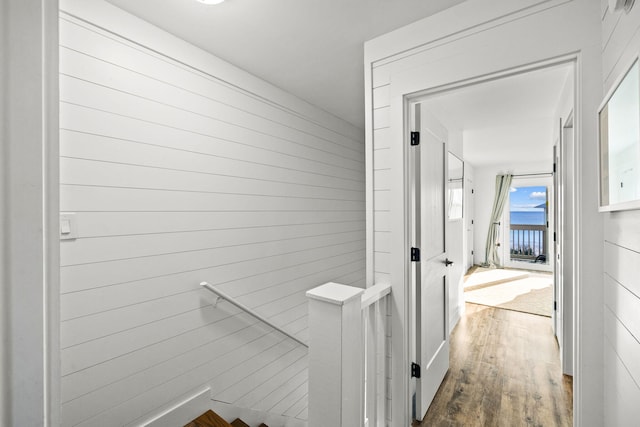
<box><xmin>424</xmin><ymin>65</ymin><xmax>572</xmax><ymax>167</ymax></box>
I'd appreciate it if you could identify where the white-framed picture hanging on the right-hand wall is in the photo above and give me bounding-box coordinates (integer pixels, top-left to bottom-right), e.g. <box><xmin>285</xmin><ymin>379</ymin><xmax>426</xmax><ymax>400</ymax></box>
<box><xmin>598</xmin><ymin>56</ymin><xmax>640</xmax><ymax>212</ymax></box>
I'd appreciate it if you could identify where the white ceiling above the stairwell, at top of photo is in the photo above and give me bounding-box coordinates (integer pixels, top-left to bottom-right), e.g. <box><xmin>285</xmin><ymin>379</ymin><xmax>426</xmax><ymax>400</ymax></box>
<box><xmin>108</xmin><ymin>0</ymin><xmax>462</xmax><ymax>129</ymax></box>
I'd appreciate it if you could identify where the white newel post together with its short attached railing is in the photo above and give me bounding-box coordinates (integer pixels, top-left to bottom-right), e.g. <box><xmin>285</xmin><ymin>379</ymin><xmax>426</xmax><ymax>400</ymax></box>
<box><xmin>307</xmin><ymin>283</ymin><xmax>391</xmax><ymax>427</ymax></box>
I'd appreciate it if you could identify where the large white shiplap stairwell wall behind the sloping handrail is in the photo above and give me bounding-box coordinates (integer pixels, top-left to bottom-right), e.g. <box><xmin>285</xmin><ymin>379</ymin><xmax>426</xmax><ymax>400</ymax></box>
<box><xmin>60</xmin><ymin>7</ymin><xmax>362</xmax><ymax>426</ymax></box>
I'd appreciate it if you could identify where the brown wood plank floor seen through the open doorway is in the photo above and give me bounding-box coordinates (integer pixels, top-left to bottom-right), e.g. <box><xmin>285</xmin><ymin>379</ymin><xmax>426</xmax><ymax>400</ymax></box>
<box><xmin>414</xmin><ymin>303</ymin><xmax>573</xmax><ymax>427</ymax></box>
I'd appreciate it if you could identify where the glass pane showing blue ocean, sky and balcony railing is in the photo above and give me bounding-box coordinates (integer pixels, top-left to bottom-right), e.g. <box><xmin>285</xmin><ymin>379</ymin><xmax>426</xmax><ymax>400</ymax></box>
<box><xmin>509</xmin><ymin>186</ymin><xmax>549</xmax><ymax>264</ymax></box>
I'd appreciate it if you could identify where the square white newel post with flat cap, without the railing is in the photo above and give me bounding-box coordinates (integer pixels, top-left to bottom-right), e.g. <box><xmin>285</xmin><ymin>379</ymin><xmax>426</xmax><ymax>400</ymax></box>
<box><xmin>307</xmin><ymin>283</ymin><xmax>364</xmax><ymax>427</ymax></box>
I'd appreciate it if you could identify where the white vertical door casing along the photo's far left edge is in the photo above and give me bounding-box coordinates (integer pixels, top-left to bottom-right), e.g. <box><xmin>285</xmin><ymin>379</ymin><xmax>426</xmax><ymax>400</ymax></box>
<box><xmin>0</xmin><ymin>0</ymin><xmax>60</xmax><ymax>426</ymax></box>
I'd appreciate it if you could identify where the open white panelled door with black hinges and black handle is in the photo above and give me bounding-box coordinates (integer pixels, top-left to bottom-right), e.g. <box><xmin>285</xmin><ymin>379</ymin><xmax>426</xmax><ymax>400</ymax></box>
<box><xmin>411</xmin><ymin>105</ymin><xmax>450</xmax><ymax>419</ymax></box>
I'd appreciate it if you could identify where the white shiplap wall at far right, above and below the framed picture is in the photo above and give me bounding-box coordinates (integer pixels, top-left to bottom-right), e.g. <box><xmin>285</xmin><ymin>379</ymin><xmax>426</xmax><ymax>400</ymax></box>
<box><xmin>602</xmin><ymin>0</ymin><xmax>640</xmax><ymax>426</ymax></box>
